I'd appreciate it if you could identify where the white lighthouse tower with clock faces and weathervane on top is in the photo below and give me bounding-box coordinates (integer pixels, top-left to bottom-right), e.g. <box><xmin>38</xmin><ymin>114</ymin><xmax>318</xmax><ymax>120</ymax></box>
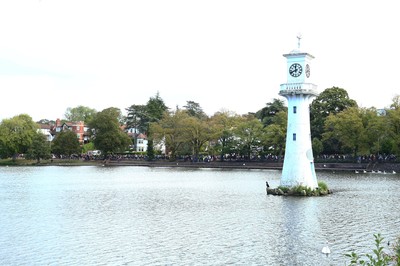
<box><xmin>279</xmin><ymin>36</ymin><xmax>318</xmax><ymax>189</ymax></box>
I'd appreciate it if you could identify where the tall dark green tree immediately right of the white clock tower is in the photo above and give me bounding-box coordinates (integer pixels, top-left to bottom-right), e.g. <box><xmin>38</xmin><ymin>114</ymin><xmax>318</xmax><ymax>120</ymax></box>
<box><xmin>310</xmin><ymin>87</ymin><xmax>357</xmax><ymax>139</ymax></box>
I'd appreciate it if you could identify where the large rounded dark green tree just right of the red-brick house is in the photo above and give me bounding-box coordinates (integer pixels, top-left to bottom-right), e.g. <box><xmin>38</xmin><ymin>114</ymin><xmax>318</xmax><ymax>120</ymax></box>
<box><xmin>88</xmin><ymin>107</ymin><xmax>132</xmax><ymax>156</ymax></box>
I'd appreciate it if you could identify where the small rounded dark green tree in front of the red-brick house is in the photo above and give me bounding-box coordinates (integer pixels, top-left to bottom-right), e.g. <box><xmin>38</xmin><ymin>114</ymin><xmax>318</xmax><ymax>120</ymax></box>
<box><xmin>52</xmin><ymin>130</ymin><xmax>81</xmax><ymax>156</ymax></box>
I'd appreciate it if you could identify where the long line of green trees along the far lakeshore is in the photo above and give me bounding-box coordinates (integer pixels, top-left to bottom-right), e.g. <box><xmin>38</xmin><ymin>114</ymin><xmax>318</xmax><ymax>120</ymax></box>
<box><xmin>0</xmin><ymin>87</ymin><xmax>400</xmax><ymax>161</ymax></box>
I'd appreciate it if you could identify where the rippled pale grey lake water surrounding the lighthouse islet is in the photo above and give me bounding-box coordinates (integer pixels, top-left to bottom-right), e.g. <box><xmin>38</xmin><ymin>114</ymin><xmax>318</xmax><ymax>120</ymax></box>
<box><xmin>0</xmin><ymin>166</ymin><xmax>400</xmax><ymax>265</ymax></box>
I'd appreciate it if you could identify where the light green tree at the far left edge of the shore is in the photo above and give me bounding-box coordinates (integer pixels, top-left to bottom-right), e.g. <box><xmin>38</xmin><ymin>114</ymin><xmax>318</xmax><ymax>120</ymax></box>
<box><xmin>0</xmin><ymin>114</ymin><xmax>38</xmax><ymax>160</ymax></box>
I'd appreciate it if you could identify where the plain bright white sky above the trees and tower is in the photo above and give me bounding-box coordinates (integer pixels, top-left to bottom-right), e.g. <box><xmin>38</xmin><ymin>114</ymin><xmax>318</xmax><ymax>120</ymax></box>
<box><xmin>0</xmin><ymin>0</ymin><xmax>400</xmax><ymax>121</ymax></box>
